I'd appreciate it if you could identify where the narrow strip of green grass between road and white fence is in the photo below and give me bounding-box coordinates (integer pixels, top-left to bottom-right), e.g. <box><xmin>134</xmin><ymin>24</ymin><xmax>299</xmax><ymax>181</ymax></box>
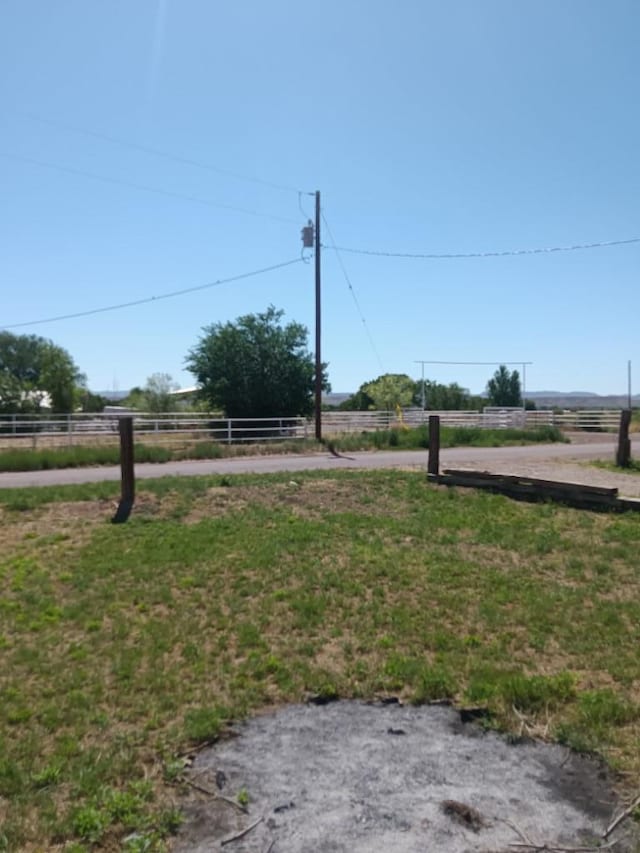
<box><xmin>0</xmin><ymin>426</ymin><xmax>566</xmax><ymax>471</ymax></box>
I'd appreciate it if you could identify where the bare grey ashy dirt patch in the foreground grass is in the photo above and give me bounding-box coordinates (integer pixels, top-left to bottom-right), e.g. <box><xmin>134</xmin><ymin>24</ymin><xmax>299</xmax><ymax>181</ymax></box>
<box><xmin>174</xmin><ymin>701</ymin><xmax>639</xmax><ymax>853</ymax></box>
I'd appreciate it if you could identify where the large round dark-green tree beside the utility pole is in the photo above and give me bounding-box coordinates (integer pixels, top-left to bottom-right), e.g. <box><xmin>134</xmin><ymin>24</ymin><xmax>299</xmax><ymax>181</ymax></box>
<box><xmin>186</xmin><ymin>305</ymin><xmax>330</xmax><ymax>418</ymax></box>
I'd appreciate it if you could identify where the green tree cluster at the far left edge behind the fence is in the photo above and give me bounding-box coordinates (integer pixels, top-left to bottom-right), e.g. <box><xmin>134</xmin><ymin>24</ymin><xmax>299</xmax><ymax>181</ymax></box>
<box><xmin>0</xmin><ymin>332</ymin><xmax>86</xmax><ymax>413</ymax></box>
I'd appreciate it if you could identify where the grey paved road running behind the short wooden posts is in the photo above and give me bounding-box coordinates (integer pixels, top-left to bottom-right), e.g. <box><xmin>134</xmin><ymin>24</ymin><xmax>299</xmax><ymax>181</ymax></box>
<box><xmin>0</xmin><ymin>437</ymin><xmax>615</xmax><ymax>489</ymax></box>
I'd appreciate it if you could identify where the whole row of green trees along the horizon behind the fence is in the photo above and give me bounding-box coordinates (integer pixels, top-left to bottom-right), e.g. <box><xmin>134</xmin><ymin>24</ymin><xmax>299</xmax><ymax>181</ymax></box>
<box><xmin>0</xmin><ymin>306</ymin><xmax>522</xmax><ymax>418</ymax></box>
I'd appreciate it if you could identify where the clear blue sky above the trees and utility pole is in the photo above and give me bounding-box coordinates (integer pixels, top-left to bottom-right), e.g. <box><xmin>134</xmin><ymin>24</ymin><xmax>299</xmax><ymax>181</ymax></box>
<box><xmin>0</xmin><ymin>0</ymin><xmax>640</xmax><ymax>393</ymax></box>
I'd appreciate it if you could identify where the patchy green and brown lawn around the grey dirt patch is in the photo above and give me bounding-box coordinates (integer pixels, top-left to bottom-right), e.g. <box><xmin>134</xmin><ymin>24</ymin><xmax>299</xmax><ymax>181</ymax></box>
<box><xmin>0</xmin><ymin>471</ymin><xmax>640</xmax><ymax>853</ymax></box>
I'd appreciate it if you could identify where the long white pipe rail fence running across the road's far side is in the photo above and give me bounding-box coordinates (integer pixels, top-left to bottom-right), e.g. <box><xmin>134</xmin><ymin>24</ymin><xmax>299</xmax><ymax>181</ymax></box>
<box><xmin>0</xmin><ymin>409</ymin><xmax>620</xmax><ymax>448</ymax></box>
